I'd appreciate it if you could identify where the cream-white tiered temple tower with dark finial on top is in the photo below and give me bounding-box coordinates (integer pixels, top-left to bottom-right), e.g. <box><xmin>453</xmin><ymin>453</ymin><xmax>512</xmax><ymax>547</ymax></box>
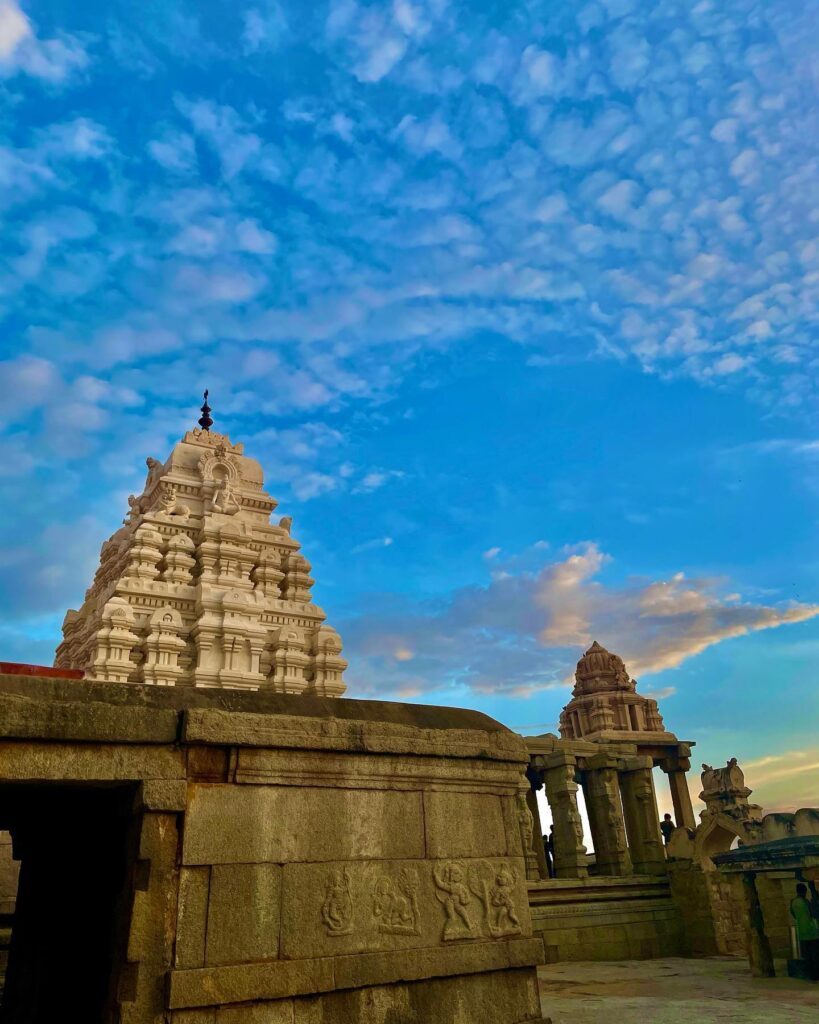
<box><xmin>54</xmin><ymin>391</ymin><xmax>347</xmax><ymax>696</ymax></box>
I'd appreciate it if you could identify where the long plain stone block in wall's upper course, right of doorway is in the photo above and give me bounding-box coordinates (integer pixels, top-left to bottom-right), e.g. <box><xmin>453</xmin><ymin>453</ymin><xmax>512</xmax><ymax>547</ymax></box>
<box><xmin>182</xmin><ymin>785</ymin><xmax>424</xmax><ymax>864</ymax></box>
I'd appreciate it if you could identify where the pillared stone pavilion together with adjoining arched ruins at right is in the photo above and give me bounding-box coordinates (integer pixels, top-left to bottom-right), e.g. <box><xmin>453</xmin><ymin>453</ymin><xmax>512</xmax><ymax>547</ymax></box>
<box><xmin>518</xmin><ymin>630</ymin><xmax>819</xmax><ymax>973</ymax></box>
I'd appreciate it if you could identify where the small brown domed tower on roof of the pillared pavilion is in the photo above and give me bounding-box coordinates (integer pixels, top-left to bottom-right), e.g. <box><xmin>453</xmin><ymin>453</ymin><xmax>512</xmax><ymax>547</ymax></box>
<box><xmin>560</xmin><ymin>640</ymin><xmax>676</xmax><ymax>740</ymax></box>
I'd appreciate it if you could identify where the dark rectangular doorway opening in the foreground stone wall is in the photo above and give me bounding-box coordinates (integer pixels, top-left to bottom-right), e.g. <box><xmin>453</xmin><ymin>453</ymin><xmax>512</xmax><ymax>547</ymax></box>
<box><xmin>0</xmin><ymin>783</ymin><xmax>135</xmax><ymax>1024</ymax></box>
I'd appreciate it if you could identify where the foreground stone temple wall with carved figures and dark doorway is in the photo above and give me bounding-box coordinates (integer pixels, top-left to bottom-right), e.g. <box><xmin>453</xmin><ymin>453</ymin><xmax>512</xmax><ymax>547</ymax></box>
<box><xmin>0</xmin><ymin>676</ymin><xmax>543</xmax><ymax>1024</ymax></box>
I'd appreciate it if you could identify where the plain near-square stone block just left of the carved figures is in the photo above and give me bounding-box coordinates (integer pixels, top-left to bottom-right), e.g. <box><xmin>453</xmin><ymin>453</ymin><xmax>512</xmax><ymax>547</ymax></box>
<box><xmin>205</xmin><ymin>864</ymin><xmax>282</xmax><ymax>965</ymax></box>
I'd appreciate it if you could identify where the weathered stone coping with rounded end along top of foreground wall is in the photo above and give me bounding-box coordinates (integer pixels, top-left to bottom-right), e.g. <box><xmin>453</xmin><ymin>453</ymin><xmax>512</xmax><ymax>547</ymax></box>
<box><xmin>0</xmin><ymin>673</ymin><xmax>528</xmax><ymax>764</ymax></box>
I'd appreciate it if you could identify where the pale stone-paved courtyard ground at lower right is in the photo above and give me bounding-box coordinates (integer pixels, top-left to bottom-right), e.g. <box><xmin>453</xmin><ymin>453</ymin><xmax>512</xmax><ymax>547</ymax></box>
<box><xmin>537</xmin><ymin>957</ymin><xmax>819</xmax><ymax>1024</ymax></box>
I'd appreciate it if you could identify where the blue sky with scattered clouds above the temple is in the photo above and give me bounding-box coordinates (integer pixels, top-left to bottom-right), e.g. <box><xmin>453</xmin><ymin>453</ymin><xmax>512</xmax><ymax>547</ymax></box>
<box><xmin>0</xmin><ymin>0</ymin><xmax>819</xmax><ymax>810</ymax></box>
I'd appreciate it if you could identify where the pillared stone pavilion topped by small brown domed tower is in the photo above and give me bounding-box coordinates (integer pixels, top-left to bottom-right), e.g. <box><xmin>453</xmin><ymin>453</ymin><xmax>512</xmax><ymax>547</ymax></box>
<box><xmin>526</xmin><ymin>641</ymin><xmax>694</xmax><ymax>961</ymax></box>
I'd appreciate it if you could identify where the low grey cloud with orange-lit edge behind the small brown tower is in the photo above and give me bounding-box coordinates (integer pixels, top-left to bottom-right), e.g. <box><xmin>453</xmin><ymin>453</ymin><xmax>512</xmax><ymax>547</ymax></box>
<box><xmin>344</xmin><ymin>543</ymin><xmax>819</xmax><ymax>696</ymax></box>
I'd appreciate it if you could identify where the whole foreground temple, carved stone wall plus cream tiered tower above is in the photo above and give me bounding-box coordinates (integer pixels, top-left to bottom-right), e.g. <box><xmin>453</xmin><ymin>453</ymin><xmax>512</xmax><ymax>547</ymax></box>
<box><xmin>0</xmin><ymin>407</ymin><xmax>545</xmax><ymax>1024</ymax></box>
